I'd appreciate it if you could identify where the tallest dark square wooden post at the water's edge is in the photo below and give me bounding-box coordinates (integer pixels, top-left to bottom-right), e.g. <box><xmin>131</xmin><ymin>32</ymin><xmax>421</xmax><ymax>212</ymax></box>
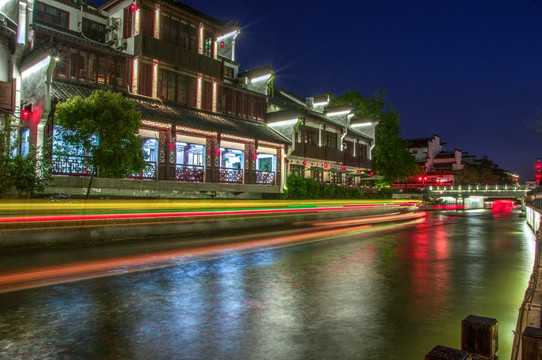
<box><xmin>461</xmin><ymin>315</ymin><xmax>499</xmax><ymax>360</ymax></box>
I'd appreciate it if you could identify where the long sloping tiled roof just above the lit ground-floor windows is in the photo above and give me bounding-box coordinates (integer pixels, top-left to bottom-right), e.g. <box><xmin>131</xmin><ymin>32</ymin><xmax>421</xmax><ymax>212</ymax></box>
<box><xmin>51</xmin><ymin>80</ymin><xmax>290</xmax><ymax>144</ymax></box>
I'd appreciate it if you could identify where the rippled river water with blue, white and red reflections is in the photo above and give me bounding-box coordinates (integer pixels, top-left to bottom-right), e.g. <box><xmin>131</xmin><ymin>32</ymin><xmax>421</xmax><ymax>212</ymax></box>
<box><xmin>0</xmin><ymin>210</ymin><xmax>535</xmax><ymax>359</ymax></box>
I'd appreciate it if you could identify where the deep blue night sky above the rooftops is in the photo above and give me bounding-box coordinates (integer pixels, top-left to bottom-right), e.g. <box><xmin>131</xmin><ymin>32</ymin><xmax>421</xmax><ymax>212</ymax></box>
<box><xmin>92</xmin><ymin>0</ymin><xmax>542</xmax><ymax>182</ymax></box>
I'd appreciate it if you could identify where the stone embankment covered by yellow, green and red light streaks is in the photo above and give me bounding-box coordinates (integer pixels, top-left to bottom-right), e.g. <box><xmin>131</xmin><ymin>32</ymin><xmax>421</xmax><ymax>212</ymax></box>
<box><xmin>0</xmin><ymin>200</ymin><xmax>419</xmax><ymax>251</ymax></box>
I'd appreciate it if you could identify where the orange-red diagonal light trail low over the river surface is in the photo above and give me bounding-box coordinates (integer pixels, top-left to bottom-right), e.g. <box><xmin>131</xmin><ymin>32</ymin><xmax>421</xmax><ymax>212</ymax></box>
<box><xmin>0</xmin><ymin>212</ymin><xmax>425</xmax><ymax>293</ymax></box>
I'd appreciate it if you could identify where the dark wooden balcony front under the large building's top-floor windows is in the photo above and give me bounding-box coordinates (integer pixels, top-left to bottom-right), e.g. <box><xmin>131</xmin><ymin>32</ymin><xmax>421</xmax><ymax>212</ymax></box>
<box><xmin>134</xmin><ymin>34</ymin><xmax>223</xmax><ymax>79</ymax></box>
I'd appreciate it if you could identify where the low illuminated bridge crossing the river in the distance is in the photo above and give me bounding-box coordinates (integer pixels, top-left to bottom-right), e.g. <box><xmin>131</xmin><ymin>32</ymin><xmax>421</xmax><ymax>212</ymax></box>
<box><xmin>427</xmin><ymin>185</ymin><xmax>530</xmax><ymax>208</ymax></box>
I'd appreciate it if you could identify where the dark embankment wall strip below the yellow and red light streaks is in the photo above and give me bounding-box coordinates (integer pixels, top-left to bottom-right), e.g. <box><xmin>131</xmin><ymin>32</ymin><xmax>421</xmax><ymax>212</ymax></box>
<box><xmin>0</xmin><ymin>205</ymin><xmax>417</xmax><ymax>252</ymax></box>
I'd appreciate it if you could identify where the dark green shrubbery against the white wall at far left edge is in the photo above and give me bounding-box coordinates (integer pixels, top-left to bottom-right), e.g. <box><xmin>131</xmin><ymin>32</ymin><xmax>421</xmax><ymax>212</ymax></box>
<box><xmin>0</xmin><ymin>117</ymin><xmax>51</xmax><ymax>196</ymax></box>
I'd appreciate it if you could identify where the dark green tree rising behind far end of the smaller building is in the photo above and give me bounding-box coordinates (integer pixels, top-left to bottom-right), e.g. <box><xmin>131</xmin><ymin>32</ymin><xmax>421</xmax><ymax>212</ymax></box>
<box><xmin>332</xmin><ymin>90</ymin><xmax>417</xmax><ymax>183</ymax></box>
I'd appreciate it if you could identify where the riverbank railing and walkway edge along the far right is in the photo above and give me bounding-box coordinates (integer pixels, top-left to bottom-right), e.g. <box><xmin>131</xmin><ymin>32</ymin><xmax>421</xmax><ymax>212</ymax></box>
<box><xmin>511</xmin><ymin>205</ymin><xmax>542</xmax><ymax>360</ymax></box>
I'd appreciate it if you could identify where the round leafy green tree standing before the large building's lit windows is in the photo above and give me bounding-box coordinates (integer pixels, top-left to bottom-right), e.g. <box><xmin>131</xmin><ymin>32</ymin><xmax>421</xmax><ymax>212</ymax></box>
<box><xmin>56</xmin><ymin>90</ymin><xmax>146</xmax><ymax>197</ymax></box>
